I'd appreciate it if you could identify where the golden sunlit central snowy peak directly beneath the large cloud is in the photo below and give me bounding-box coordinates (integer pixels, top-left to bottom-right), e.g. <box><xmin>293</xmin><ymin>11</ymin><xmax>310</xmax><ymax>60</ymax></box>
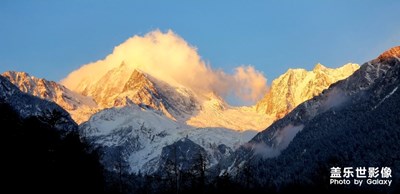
<box><xmin>59</xmin><ymin>59</ymin><xmax>274</xmax><ymax>131</ymax></box>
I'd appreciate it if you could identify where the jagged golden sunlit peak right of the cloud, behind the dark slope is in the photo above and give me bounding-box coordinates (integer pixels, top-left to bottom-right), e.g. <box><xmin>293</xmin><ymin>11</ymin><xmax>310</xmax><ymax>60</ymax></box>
<box><xmin>256</xmin><ymin>63</ymin><xmax>359</xmax><ymax>119</ymax></box>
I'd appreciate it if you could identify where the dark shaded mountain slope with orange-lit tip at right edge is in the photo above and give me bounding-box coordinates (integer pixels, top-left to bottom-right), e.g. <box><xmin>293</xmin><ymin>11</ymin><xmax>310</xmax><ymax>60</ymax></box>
<box><xmin>218</xmin><ymin>46</ymin><xmax>400</xmax><ymax>192</ymax></box>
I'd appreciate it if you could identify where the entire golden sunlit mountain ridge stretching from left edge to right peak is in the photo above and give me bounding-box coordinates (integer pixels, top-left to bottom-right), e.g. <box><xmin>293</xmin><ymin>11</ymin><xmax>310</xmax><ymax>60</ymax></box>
<box><xmin>3</xmin><ymin>62</ymin><xmax>358</xmax><ymax>131</ymax></box>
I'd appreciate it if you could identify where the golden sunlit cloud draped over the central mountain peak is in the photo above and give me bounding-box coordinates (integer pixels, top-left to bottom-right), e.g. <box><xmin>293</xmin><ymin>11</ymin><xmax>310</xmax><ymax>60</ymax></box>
<box><xmin>62</xmin><ymin>30</ymin><xmax>267</xmax><ymax>102</ymax></box>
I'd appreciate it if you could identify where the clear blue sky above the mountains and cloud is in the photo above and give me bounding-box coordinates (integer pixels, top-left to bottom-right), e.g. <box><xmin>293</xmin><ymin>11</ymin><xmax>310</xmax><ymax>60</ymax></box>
<box><xmin>0</xmin><ymin>0</ymin><xmax>400</xmax><ymax>83</ymax></box>
